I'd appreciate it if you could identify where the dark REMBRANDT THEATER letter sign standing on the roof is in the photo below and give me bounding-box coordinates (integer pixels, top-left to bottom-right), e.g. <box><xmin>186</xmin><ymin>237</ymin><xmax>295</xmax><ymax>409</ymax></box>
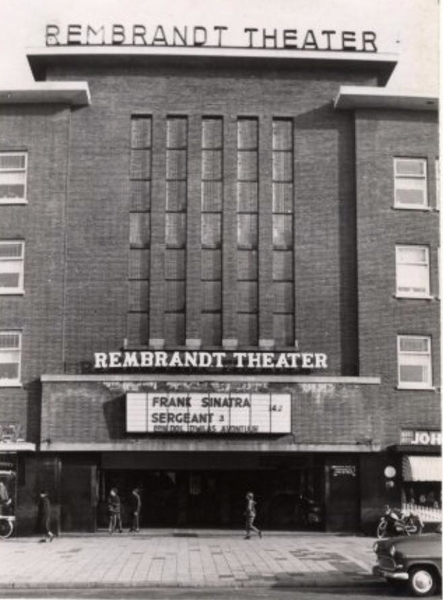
<box><xmin>45</xmin><ymin>23</ymin><xmax>378</xmax><ymax>53</ymax></box>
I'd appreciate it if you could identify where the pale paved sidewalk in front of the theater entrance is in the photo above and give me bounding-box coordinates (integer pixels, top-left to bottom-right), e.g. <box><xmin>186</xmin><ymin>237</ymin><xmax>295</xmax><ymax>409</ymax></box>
<box><xmin>0</xmin><ymin>530</ymin><xmax>377</xmax><ymax>589</ymax></box>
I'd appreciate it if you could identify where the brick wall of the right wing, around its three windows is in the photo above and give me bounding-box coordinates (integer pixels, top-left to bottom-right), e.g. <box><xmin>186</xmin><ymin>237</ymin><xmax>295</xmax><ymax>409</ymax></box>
<box><xmin>356</xmin><ymin>111</ymin><xmax>440</xmax><ymax>443</ymax></box>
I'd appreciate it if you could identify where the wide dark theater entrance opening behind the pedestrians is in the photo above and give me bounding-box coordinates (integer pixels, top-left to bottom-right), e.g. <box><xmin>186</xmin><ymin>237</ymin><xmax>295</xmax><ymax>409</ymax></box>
<box><xmin>99</xmin><ymin>467</ymin><xmax>324</xmax><ymax>530</ymax></box>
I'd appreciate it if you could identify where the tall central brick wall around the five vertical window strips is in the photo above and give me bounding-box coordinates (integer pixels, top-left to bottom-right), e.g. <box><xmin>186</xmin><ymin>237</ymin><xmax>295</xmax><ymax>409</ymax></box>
<box><xmin>46</xmin><ymin>59</ymin><xmax>374</xmax><ymax>374</ymax></box>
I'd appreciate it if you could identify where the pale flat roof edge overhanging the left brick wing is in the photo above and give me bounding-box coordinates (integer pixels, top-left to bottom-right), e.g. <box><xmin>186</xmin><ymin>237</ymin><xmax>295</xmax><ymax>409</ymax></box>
<box><xmin>0</xmin><ymin>81</ymin><xmax>91</xmax><ymax>106</ymax></box>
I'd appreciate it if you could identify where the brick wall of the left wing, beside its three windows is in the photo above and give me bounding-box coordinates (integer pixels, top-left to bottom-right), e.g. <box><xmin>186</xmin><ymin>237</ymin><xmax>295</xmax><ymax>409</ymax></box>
<box><xmin>0</xmin><ymin>106</ymin><xmax>70</xmax><ymax>441</ymax></box>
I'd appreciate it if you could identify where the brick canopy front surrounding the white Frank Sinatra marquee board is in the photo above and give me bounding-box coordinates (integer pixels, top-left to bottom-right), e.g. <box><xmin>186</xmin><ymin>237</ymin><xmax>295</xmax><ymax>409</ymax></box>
<box><xmin>42</xmin><ymin>376</ymin><xmax>380</xmax><ymax>450</ymax></box>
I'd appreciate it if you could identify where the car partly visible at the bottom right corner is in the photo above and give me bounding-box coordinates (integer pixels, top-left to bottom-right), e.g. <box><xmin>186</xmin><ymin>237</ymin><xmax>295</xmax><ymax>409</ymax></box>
<box><xmin>373</xmin><ymin>525</ymin><xmax>442</xmax><ymax>598</ymax></box>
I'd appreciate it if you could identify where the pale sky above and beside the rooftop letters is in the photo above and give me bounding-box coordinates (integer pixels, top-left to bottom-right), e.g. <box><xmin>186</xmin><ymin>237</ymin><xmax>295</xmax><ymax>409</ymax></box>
<box><xmin>0</xmin><ymin>0</ymin><xmax>440</xmax><ymax>95</ymax></box>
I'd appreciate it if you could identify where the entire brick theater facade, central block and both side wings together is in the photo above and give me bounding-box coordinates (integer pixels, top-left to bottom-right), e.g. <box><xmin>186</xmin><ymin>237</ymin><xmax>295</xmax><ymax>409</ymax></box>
<box><xmin>0</xmin><ymin>50</ymin><xmax>440</xmax><ymax>528</ymax></box>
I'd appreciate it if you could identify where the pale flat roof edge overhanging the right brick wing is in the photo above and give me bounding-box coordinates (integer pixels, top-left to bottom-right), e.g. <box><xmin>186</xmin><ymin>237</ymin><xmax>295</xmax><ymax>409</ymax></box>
<box><xmin>334</xmin><ymin>86</ymin><xmax>439</xmax><ymax>111</ymax></box>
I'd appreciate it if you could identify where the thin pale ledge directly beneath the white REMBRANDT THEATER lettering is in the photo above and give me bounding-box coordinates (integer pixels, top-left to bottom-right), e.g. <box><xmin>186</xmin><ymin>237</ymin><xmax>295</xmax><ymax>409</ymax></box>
<box><xmin>41</xmin><ymin>373</ymin><xmax>381</xmax><ymax>385</ymax></box>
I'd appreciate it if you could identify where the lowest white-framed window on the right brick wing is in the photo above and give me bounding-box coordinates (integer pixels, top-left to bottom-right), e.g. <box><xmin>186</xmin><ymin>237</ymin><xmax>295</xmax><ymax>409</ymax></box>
<box><xmin>398</xmin><ymin>335</ymin><xmax>432</xmax><ymax>389</ymax></box>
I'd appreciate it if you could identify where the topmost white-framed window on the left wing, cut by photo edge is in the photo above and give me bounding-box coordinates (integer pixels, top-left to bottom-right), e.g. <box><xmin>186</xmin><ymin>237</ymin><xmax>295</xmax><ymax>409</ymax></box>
<box><xmin>0</xmin><ymin>152</ymin><xmax>28</xmax><ymax>204</ymax></box>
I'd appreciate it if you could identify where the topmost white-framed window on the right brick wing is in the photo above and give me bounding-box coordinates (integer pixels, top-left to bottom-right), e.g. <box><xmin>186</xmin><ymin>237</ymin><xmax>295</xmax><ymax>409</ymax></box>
<box><xmin>394</xmin><ymin>158</ymin><xmax>428</xmax><ymax>209</ymax></box>
